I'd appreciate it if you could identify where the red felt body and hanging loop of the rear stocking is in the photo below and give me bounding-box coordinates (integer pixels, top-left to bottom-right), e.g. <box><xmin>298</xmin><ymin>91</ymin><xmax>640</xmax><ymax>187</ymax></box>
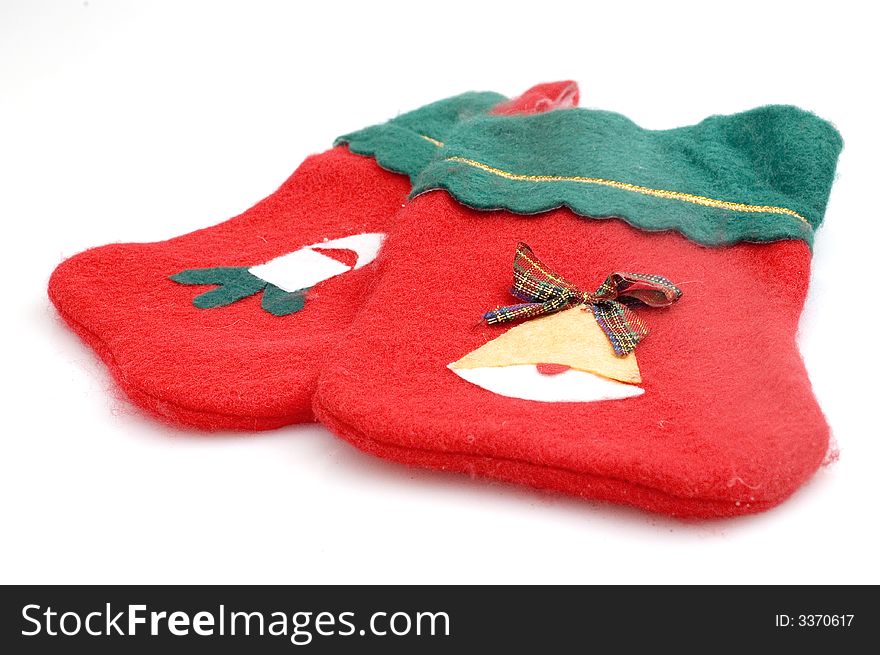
<box><xmin>49</xmin><ymin>83</ymin><xmax>577</xmax><ymax>430</ymax></box>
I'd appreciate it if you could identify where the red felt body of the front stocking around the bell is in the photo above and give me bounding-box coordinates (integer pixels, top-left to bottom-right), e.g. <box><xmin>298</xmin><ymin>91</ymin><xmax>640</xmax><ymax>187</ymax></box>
<box><xmin>314</xmin><ymin>191</ymin><xmax>828</xmax><ymax>517</ymax></box>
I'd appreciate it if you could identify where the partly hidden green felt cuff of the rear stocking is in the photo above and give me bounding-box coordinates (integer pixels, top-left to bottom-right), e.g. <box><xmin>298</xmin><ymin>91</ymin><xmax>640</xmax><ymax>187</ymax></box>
<box><xmin>334</xmin><ymin>91</ymin><xmax>506</xmax><ymax>179</ymax></box>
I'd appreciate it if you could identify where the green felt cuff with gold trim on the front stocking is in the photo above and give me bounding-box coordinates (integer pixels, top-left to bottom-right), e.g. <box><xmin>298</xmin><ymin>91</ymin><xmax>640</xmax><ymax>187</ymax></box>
<box><xmin>413</xmin><ymin>105</ymin><xmax>843</xmax><ymax>246</ymax></box>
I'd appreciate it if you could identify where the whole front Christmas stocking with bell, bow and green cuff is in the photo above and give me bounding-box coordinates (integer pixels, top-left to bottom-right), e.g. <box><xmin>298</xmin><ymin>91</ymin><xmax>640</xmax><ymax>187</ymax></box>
<box><xmin>314</xmin><ymin>106</ymin><xmax>841</xmax><ymax>517</ymax></box>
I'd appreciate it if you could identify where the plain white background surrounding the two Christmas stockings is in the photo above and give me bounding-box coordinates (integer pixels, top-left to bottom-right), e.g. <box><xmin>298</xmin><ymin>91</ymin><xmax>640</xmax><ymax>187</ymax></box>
<box><xmin>0</xmin><ymin>0</ymin><xmax>880</xmax><ymax>583</ymax></box>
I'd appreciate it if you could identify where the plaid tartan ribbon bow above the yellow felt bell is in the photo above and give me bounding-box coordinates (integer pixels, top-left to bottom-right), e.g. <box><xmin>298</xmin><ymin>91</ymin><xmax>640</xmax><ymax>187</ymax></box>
<box><xmin>483</xmin><ymin>243</ymin><xmax>681</xmax><ymax>357</ymax></box>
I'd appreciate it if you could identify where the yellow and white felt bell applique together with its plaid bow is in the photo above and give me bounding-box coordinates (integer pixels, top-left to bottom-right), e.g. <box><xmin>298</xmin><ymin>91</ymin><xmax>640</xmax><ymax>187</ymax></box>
<box><xmin>449</xmin><ymin>243</ymin><xmax>681</xmax><ymax>402</ymax></box>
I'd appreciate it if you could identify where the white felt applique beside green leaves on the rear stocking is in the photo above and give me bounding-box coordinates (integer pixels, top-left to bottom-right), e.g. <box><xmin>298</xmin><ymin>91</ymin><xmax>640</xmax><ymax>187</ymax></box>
<box><xmin>248</xmin><ymin>232</ymin><xmax>385</xmax><ymax>291</ymax></box>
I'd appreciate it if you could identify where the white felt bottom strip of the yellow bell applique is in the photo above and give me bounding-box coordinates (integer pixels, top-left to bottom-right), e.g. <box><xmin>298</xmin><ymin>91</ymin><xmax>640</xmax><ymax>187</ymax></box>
<box><xmin>449</xmin><ymin>364</ymin><xmax>645</xmax><ymax>403</ymax></box>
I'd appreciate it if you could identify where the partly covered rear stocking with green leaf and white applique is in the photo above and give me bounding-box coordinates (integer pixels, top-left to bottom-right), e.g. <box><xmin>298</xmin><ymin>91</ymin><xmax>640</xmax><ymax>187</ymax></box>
<box><xmin>49</xmin><ymin>82</ymin><xmax>577</xmax><ymax>430</ymax></box>
